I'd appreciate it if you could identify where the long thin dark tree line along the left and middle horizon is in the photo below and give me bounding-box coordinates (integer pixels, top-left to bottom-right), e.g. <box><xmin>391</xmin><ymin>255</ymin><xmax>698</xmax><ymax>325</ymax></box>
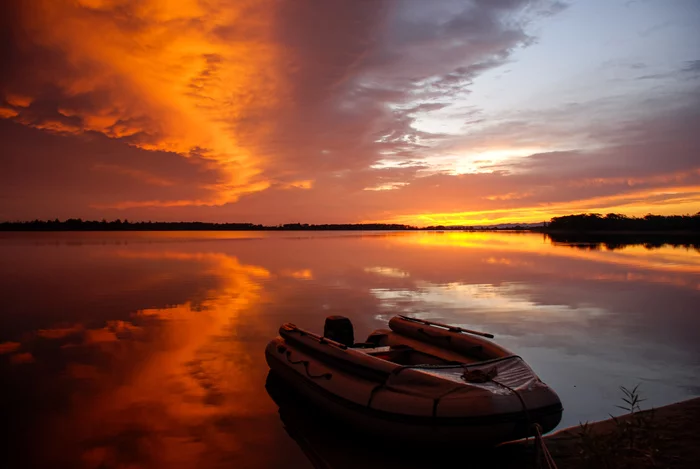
<box><xmin>0</xmin><ymin>218</ymin><xmax>417</xmax><ymax>231</ymax></box>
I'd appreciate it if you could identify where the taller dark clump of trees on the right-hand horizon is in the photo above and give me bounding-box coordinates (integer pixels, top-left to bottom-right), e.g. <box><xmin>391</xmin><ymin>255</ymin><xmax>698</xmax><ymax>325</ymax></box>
<box><xmin>545</xmin><ymin>212</ymin><xmax>700</xmax><ymax>232</ymax></box>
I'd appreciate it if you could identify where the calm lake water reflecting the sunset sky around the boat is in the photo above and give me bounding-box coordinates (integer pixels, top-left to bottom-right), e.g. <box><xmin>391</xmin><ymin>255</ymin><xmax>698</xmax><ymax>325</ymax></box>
<box><xmin>0</xmin><ymin>232</ymin><xmax>700</xmax><ymax>468</ymax></box>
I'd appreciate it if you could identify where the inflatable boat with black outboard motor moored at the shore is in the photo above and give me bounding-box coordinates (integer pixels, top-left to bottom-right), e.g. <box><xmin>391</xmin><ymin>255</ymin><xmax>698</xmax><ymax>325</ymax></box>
<box><xmin>265</xmin><ymin>316</ymin><xmax>562</xmax><ymax>445</ymax></box>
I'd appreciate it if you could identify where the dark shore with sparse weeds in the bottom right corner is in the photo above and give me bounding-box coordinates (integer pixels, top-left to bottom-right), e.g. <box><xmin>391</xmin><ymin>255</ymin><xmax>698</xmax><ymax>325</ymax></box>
<box><xmin>498</xmin><ymin>397</ymin><xmax>700</xmax><ymax>469</ymax></box>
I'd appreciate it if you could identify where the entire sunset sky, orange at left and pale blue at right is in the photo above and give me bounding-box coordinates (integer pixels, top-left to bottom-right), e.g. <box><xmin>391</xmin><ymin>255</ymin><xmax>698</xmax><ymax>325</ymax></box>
<box><xmin>0</xmin><ymin>0</ymin><xmax>700</xmax><ymax>226</ymax></box>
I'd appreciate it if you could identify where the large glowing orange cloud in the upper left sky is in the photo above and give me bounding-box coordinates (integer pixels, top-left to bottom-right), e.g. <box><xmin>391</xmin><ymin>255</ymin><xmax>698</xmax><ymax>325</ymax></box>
<box><xmin>0</xmin><ymin>0</ymin><xmax>285</xmax><ymax>207</ymax></box>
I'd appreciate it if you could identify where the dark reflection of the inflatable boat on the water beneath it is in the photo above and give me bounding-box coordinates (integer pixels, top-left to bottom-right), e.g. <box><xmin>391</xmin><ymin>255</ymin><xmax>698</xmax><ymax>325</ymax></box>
<box><xmin>265</xmin><ymin>372</ymin><xmax>533</xmax><ymax>469</ymax></box>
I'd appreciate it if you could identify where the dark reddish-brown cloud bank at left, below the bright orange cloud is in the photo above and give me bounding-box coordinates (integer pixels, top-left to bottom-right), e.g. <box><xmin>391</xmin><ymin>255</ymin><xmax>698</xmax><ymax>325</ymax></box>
<box><xmin>0</xmin><ymin>120</ymin><xmax>221</xmax><ymax>219</ymax></box>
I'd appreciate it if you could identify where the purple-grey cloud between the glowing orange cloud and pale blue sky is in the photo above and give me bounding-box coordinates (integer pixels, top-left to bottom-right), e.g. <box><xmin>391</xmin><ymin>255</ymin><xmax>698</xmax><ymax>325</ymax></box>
<box><xmin>252</xmin><ymin>1</ymin><xmax>556</xmax><ymax>183</ymax></box>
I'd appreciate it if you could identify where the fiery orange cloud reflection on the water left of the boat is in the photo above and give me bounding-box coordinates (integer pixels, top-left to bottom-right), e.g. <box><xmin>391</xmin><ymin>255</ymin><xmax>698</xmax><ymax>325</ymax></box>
<box><xmin>2</xmin><ymin>246</ymin><xmax>306</xmax><ymax>467</ymax></box>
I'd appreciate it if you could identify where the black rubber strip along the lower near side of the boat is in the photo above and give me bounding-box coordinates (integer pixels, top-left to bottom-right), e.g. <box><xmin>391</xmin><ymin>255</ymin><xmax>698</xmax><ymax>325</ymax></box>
<box><xmin>270</xmin><ymin>356</ymin><xmax>563</xmax><ymax>426</ymax></box>
